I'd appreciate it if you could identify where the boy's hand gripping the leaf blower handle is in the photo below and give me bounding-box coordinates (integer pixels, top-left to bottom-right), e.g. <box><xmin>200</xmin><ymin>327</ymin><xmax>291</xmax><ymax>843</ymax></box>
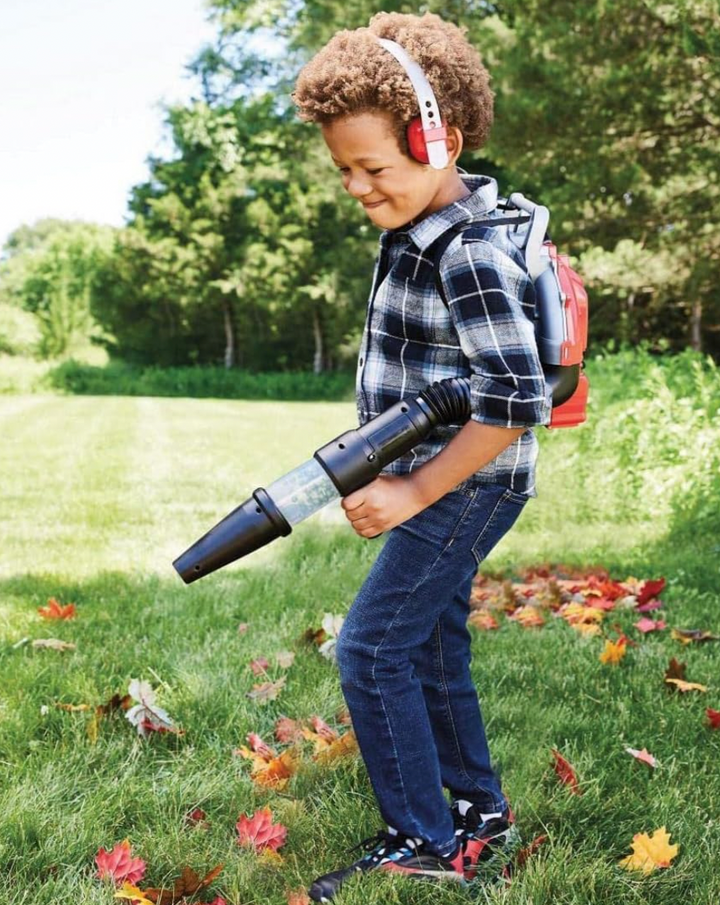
<box><xmin>340</xmin><ymin>475</ymin><xmax>427</xmax><ymax>538</ymax></box>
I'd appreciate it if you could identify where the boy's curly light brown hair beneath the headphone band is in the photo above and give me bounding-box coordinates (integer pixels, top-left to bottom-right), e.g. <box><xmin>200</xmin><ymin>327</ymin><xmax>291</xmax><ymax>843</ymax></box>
<box><xmin>291</xmin><ymin>12</ymin><xmax>495</xmax><ymax>157</ymax></box>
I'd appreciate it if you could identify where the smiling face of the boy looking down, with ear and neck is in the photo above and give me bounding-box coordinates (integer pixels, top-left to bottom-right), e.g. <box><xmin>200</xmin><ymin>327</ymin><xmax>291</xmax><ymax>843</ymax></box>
<box><xmin>322</xmin><ymin>112</ymin><xmax>462</xmax><ymax>229</ymax></box>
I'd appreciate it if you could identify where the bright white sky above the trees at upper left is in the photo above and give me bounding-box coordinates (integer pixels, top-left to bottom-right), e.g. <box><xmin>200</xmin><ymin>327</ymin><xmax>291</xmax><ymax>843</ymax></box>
<box><xmin>0</xmin><ymin>0</ymin><xmax>225</xmax><ymax>247</ymax></box>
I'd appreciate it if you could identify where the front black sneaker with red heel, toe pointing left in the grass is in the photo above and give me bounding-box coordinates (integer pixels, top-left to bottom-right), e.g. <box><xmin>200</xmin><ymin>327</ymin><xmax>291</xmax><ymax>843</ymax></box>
<box><xmin>308</xmin><ymin>830</ymin><xmax>465</xmax><ymax>902</ymax></box>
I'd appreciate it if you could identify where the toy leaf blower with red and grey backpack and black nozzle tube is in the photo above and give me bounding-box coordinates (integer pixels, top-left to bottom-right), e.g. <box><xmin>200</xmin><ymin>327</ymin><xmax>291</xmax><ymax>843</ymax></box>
<box><xmin>173</xmin><ymin>194</ymin><xmax>588</xmax><ymax>584</ymax></box>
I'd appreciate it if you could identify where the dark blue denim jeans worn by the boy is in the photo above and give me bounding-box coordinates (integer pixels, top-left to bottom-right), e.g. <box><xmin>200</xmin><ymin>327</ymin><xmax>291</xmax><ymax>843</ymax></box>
<box><xmin>336</xmin><ymin>484</ymin><xmax>529</xmax><ymax>856</ymax></box>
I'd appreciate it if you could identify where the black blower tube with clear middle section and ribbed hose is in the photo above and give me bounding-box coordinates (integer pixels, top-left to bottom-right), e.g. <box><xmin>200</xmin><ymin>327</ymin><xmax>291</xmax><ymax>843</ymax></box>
<box><xmin>173</xmin><ymin>365</ymin><xmax>580</xmax><ymax>584</ymax></box>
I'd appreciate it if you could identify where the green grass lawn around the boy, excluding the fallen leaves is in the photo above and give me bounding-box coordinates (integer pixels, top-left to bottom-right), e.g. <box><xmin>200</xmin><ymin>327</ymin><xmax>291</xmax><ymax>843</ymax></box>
<box><xmin>0</xmin><ymin>390</ymin><xmax>720</xmax><ymax>905</ymax></box>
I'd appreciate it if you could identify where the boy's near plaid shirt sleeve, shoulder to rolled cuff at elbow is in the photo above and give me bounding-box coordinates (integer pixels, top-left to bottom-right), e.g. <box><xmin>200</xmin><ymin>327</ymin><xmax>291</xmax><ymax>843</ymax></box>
<box><xmin>440</xmin><ymin>241</ymin><xmax>551</xmax><ymax>428</ymax></box>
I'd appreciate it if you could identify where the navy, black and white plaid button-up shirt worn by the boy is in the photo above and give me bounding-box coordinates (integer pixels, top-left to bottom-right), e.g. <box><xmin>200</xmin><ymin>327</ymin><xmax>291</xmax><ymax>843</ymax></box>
<box><xmin>356</xmin><ymin>173</ymin><xmax>551</xmax><ymax>497</ymax></box>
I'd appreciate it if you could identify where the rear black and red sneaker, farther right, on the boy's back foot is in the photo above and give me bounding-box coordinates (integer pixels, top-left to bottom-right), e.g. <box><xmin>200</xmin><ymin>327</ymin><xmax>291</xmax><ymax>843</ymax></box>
<box><xmin>451</xmin><ymin>801</ymin><xmax>520</xmax><ymax>883</ymax></box>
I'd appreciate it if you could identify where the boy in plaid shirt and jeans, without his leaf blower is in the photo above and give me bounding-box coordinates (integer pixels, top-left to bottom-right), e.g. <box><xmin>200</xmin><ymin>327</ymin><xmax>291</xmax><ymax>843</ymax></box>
<box><xmin>293</xmin><ymin>13</ymin><xmax>550</xmax><ymax>902</ymax></box>
